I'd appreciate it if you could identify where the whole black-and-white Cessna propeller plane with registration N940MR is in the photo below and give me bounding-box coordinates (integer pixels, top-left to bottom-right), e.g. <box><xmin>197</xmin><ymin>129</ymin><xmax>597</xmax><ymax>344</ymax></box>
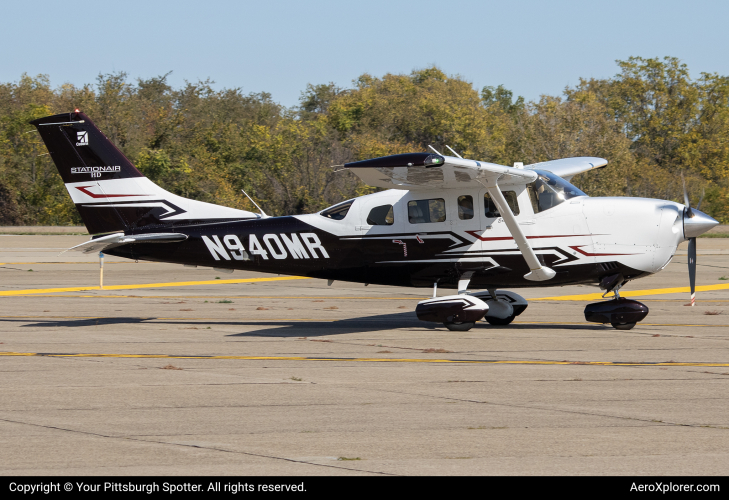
<box><xmin>31</xmin><ymin>110</ymin><xmax>718</xmax><ymax>331</ymax></box>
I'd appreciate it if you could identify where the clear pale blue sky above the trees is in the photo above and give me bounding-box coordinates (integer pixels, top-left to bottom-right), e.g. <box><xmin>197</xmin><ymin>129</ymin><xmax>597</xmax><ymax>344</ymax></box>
<box><xmin>0</xmin><ymin>0</ymin><xmax>729</xmax><ymax>106</ymax></box>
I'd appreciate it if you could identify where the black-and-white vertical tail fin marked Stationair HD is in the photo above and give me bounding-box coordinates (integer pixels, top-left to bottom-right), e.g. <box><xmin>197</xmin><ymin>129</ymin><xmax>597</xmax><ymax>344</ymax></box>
<box><xmin>30</xmin><ymin>110</ymin><xmax>258</xmax><ymax>234</ymax></box>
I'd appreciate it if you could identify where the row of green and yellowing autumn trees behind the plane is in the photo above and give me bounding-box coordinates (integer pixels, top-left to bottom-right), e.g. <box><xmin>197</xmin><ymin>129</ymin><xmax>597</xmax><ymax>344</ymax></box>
<box><xmin>0</xmin><ymin>57</ymin><xmax>729</xmax><ymax>225</ymax></box>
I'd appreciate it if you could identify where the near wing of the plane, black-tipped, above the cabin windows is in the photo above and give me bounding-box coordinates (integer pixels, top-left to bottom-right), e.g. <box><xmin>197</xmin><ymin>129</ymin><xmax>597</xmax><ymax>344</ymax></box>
<box><xmin>344</xmin><ymin>153</ymin><xmax>537</xmax><ymax>190</ymax></box>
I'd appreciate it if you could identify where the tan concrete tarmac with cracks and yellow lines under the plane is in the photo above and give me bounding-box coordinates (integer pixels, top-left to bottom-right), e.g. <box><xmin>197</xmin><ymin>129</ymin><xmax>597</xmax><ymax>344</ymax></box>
<box><xmin>0</xmin><ymin>235</ymin><xmax>729</xmax><ymax>475</ymax></box>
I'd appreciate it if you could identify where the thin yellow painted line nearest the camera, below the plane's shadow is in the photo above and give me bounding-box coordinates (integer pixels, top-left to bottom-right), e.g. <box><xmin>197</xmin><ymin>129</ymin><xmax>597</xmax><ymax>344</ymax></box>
<box><xmin>0</xmin><ymin>352</ymin><xmax>729</xmax><ymax>367</ymax></box>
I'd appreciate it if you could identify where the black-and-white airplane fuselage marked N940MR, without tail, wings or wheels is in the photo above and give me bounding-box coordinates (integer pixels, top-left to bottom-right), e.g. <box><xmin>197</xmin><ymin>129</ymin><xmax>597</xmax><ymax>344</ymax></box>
<box><xmin>107</xmin><ymin>187</ymin><xmax>684</xmax><ymax>289</ymax></box>
